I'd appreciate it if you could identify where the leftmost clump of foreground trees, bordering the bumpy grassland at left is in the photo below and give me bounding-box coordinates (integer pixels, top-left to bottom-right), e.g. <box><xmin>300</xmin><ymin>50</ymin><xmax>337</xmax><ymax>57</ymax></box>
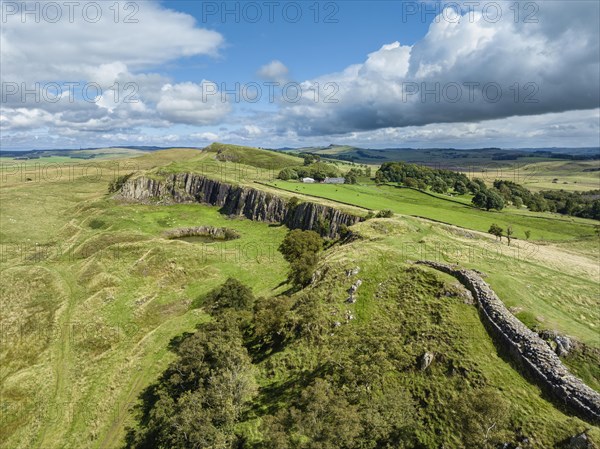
<box><xmin>126</xmin><ymin>279</ymin><xmax>258</xmax><ymax>449</ymax></box>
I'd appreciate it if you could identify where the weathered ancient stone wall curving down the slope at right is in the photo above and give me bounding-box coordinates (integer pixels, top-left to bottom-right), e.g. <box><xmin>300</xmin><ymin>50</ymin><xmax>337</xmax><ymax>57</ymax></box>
<box><xmin>417</xmin><ymin>261</ymin><xmax>600</xmax><ymax>422</ymax></box>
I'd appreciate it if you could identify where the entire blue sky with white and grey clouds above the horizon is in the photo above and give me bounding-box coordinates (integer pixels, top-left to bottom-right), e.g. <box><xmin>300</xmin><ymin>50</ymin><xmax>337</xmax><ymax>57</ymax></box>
<box><xmin>0</xmin><ymin>0</ymin><xmax>600</xmax><ymax>150</ymax></box>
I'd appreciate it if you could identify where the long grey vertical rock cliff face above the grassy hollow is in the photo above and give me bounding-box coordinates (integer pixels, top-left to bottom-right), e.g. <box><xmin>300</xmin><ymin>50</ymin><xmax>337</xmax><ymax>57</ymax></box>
<box><xmin>119</xmin><ymin>173</ymin><xmax>360</xmax><ymax>238</ymax></box>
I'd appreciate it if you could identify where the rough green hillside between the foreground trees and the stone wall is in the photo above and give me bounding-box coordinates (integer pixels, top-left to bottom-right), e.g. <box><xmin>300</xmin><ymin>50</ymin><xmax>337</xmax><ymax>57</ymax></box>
<box><xmin>245</xmin><ymin>226</ymin><xmax>600</xmax><ymax>448</ymax></box>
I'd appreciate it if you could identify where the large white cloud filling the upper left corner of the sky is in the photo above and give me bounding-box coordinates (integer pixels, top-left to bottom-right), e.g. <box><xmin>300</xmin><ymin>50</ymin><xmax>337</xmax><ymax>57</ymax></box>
<box><xmin>0</xmin><ymin>1</ymin><xmax>224</xmax><ymax>83</ymax></box>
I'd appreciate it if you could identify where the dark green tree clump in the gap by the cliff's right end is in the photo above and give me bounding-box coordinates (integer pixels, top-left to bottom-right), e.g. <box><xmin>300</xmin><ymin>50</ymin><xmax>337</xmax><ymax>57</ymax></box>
<box><xmin>279</xmin><ymin>229</ymin><xmax>323</xmax><ymax>288</ymax></box>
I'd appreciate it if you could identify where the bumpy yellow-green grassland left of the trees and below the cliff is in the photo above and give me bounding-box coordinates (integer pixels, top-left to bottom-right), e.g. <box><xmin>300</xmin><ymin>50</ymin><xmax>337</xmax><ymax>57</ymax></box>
<box><xmin>0</xmin><ymin>151</ymin><xmax>286</xmax><ymax>449</ymax></box>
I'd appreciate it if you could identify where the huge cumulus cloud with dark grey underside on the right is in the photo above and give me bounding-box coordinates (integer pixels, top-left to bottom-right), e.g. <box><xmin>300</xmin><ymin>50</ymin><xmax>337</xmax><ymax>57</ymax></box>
<box><xmin>278</xmin><ymin>2</ymin><xmax>600</xmax><ymax>136</ymax></box>
